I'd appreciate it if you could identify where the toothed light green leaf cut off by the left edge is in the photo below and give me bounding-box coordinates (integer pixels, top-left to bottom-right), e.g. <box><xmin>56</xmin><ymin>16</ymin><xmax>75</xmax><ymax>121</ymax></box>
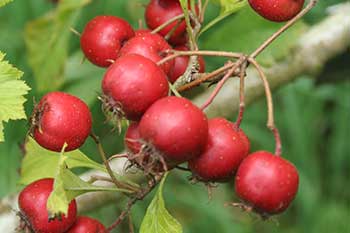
<box><xmin>0</xmin><ymin>52</ymin><xmax>30</xmax><ymax>142</ymax></box>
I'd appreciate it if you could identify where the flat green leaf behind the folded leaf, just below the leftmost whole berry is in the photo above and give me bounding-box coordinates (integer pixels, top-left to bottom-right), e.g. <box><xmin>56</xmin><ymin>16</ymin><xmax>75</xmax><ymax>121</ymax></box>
<box><xmin>19</xmin><ymin>137</ymin><xmax>138</xmax><ymax>187</ymax></box>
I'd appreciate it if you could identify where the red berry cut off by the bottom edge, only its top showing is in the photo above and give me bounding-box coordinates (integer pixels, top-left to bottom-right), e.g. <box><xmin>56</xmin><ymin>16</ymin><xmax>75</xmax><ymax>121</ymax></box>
<box><xmin>67</xmin><ymin>216</ymin><xmax>107</xmax><ymax>233</ymax></box>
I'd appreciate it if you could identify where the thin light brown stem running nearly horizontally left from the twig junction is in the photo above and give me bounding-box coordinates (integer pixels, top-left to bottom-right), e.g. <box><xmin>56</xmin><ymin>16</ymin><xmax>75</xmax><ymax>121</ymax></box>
<box><xmin>157</xmin><ymin>50</ymin><xmax>242</xmax><ymax>65</ymax></box>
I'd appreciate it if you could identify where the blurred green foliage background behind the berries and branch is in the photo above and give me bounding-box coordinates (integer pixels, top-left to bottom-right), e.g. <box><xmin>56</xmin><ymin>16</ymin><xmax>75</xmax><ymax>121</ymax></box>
<box><xmin>0</xmin><ymin>0</ymin><xmax>350</xmax><ymax>233</ymax></box>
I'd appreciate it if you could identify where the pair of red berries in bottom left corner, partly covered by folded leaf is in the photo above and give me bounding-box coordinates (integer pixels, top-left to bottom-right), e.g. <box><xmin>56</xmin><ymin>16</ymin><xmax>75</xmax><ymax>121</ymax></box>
<box><xmin>18</xmin><ymin>178</ymin><xmax>106</xmax><ymax>233</ymax></box>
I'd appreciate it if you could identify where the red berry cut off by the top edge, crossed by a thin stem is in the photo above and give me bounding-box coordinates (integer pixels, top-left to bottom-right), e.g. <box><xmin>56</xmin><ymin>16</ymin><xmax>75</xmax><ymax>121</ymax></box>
<box><xmin>145</xmin><ymin>0</ymin><xmax>187</xmax><ymax>45</ymax></box>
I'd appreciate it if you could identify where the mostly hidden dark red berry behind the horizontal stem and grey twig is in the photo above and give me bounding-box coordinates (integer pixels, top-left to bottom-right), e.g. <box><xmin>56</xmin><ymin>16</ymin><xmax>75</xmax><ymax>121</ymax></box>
<box><xmin>168</xmin><ymin>46</ymin><xmax>205</xmax><ymax>83</ymax></box>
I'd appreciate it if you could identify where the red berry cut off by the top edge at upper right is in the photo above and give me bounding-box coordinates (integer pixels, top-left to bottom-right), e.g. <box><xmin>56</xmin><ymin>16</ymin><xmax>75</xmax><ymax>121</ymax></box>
<box><xmin>249</xmin><ymin>0</ymin><xmax>304</xmax><ymax>22</ymax></box>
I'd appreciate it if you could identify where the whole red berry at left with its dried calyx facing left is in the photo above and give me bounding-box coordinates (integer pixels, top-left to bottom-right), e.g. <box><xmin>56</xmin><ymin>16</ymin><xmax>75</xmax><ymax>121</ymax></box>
<box><xmin>32</xmin><ymin>92</ymin><xmax>92</xmax><ymax>152</ymax></box>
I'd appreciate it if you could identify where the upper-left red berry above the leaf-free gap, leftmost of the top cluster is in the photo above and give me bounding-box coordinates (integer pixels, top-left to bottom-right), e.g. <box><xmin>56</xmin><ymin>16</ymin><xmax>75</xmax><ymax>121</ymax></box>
<box><xmin>80</xmin><ymin>15</ymin><xmax>134</xmax><ymax>67</ymax></box>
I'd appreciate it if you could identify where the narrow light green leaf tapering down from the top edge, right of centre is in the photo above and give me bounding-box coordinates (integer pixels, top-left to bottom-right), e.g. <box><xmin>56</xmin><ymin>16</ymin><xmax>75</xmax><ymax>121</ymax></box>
<box><xmin>199</xmin><ymin>0</ymin><xmax>247</xmax><ymax>35</ymax></box>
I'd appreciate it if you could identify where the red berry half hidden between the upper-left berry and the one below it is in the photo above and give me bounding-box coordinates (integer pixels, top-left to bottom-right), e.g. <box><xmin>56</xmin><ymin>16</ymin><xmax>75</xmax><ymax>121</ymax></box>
<box><xmin>119</xmin><ymin>31</ymin><xmax>174</xmax><ymax>74</ymax></box>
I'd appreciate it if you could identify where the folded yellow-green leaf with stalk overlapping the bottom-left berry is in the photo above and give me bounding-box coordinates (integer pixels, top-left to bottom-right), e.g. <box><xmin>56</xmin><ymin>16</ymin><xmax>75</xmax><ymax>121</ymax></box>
<box><xmin>47</xmin><ymin>150</ymin><xmax>130</xmax><ymax>217</ymax></box>
